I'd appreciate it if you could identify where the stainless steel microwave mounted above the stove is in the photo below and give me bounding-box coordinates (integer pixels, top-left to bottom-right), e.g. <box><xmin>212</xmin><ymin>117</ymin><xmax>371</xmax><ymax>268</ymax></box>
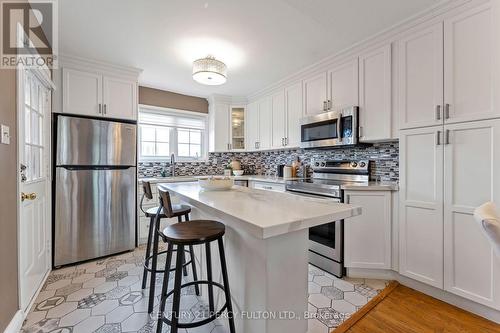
<box><xmin>300</xmin><ymin>106</ymin><xmax>359</xmax><ymax>148</ymax></box>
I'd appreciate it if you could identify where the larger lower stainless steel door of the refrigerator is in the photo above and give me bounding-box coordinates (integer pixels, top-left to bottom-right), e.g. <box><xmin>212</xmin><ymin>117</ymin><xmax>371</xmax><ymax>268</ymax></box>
<box><xmin>54</xmin><ymin>167</ymin><xmax>137</xmax><ymax>266</ymax></box>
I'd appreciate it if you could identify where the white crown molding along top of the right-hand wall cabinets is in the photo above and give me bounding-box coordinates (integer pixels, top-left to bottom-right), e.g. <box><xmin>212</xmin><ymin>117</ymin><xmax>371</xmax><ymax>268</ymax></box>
<box><xmin>247</xmin><ymin>0</ymin><xmax>480</xmax><ymax>102</ymax></box>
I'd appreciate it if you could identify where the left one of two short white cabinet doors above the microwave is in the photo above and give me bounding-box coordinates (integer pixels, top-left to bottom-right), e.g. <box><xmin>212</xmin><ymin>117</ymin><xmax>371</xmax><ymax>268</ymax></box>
<box><xmin>304</xmin><ymin>72</ymin><xmax>327</xmax><ymax>116</ymax></box>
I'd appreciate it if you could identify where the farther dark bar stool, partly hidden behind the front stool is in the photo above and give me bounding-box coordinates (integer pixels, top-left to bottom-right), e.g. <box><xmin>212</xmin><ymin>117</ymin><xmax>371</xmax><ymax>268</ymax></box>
<box><xmin>140</xmin><ymin>181</ymin><xmax>200</xmax><ymax>313</ymax></box>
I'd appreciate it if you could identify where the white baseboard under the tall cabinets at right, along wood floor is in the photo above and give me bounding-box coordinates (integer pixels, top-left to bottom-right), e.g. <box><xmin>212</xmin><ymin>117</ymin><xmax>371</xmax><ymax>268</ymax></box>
<box><xmin>347</xmin><ymin>268</ymin><xmax>500</xmax><ymax>324</ymax></box>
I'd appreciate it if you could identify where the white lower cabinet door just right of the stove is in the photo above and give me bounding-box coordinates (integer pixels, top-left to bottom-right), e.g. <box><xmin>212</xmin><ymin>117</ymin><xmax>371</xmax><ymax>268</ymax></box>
<box><xmin>344</xmin><ymin>191</ymin><xmax>392</xmax><ymax>269</ymax></box>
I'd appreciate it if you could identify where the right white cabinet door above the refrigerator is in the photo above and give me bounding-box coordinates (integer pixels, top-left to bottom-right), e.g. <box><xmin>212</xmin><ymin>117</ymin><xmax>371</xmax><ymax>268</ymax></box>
<box><xmin>102</xmin><ymin>76</ymin><xmax>137</xmax><ymax>120</ymax></box>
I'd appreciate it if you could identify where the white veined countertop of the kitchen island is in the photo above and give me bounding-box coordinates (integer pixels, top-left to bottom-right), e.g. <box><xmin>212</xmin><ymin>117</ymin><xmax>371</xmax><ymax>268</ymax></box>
<box><xmin>158</xmin><ymin>182</ymin><xmax>361</xmax><ymax>239</ymax></box>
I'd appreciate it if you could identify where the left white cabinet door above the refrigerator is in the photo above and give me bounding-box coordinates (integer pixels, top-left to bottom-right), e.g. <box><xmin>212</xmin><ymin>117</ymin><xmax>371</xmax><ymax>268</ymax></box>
<box><xmin>62</xmin><ymin>68</ymin><xmax>103</xmax><ymax>116</ymax></box>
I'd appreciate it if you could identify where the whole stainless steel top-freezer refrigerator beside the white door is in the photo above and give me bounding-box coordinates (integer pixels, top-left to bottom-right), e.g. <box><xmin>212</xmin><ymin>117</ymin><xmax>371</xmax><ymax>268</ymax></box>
<box><xmin>53</xmin><ymin>115</ymin><xmax>137</xmax><ymax>267</ymax></box>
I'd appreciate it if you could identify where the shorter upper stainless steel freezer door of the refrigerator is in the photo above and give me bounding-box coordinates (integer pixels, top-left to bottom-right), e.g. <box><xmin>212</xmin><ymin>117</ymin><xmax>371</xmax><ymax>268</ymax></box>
<box><xmin>56</xmin><ymin>116</ymin><xmax>137</xmax><ymax>166</ymax></box>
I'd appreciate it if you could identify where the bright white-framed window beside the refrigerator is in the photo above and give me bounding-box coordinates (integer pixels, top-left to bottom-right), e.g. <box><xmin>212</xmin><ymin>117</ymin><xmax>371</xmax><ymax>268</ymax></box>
<box><xmin>139</xmin><ymin>106</ymin><xmax>207</xmax><ymax>161</ymax></box>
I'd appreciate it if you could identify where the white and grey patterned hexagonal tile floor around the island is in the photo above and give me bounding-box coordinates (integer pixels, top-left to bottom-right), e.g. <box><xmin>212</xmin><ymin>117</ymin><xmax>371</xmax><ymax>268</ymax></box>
<box><xmin>22</xmin><ymin>248</ymin><xmax>386</xmax><ymax>333</ymax></box>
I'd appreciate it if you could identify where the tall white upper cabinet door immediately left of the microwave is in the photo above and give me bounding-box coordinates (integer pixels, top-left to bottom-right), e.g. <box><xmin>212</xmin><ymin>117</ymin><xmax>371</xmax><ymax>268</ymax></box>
<box><xmin>285</xmin><ymin>82</ymin><xmax>303</xmax><ymax>147</ymax></box>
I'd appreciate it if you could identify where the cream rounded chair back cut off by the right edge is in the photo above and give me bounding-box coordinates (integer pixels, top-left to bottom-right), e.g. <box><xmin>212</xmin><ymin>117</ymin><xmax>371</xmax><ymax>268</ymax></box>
<box><xmin>474</xmin><ymin>202</ymin><xmax>500</xmax><ymax>257</ymax></box>
